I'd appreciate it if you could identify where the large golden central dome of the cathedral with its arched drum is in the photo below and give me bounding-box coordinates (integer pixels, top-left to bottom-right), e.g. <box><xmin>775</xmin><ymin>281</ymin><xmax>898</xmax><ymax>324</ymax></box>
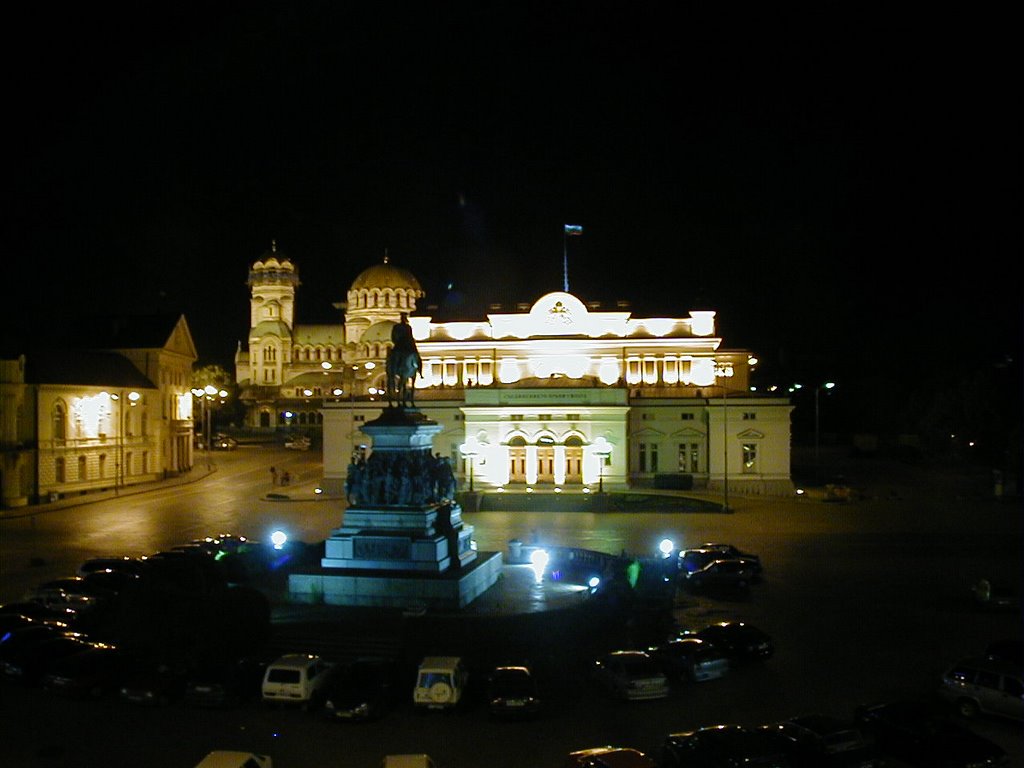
<box><xmin>345</xmin><ymin>254</ymin><xmax>425</xmax><ymax>344</ymax></box>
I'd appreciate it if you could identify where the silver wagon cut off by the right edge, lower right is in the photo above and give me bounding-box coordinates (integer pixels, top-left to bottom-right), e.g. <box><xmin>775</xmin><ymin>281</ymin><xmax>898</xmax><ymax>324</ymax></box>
<box><xmin>939</xmin><ymin>657</ymin><xmax>1024</xmax><ymax>720</ymax></box>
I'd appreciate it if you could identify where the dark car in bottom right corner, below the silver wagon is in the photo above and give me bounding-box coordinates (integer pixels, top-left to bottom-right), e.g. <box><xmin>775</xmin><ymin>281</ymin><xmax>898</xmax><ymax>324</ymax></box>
<box><xmin>854</xmin><ymin>699</ymin><xmax>1009</xmax><ymax>768</ymax></box>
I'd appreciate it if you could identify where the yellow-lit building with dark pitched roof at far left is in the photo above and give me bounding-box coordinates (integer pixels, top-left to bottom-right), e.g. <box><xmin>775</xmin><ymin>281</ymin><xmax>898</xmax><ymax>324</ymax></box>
<box><xmin>0</xmin><ymin>315</ymin><xmax>197</xmax><ymax>507</ymax></box>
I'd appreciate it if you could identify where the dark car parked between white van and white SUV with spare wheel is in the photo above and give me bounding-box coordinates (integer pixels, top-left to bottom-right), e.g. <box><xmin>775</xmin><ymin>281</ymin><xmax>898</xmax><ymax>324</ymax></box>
<box><xmin>324</xmin><ymin>657</ymin><xmax>399</xmax><ymax>722</ymax></box>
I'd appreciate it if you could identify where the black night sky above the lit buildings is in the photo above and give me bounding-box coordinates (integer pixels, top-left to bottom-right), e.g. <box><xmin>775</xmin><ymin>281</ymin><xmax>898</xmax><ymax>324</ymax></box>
<box><xmin>3</xmin><ymin>2</ymin><xmax>1024</xmax><ymax>391</ymax></box>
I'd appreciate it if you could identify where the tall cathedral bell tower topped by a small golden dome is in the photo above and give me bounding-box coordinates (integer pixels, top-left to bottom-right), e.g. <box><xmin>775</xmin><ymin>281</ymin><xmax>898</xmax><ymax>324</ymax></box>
<box><xmin>248</xmin><ymin>241</ymin><xmax>299</xmax><ymax>387</ymax></box>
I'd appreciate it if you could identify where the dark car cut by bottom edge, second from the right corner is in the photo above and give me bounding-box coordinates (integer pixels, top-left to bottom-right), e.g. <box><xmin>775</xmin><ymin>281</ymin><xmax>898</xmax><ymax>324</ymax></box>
<box><xmin>762</xmin><ymin>713</ymin><xmax>885</xmax><ymax>768</ymax></box>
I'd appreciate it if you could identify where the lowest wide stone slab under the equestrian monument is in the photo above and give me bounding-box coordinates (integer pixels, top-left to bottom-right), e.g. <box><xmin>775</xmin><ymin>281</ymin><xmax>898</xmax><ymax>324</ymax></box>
<box><xmin>288</xmin><ymin>552</ymin><xmax>502</xmax><ymax>610</ymax></box>
